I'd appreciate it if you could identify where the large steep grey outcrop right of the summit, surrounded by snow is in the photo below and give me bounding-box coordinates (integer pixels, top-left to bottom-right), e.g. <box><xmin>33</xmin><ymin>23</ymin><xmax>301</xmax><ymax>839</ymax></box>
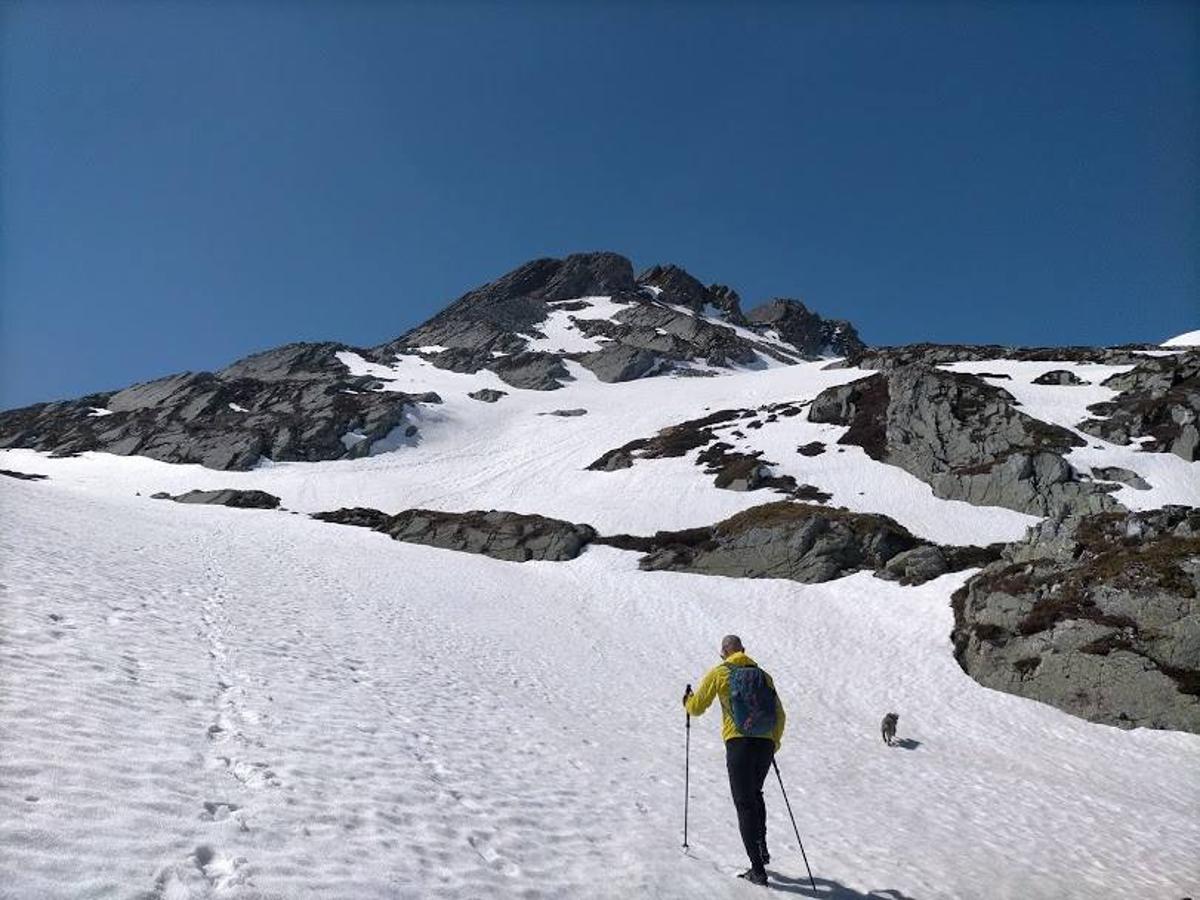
<box><xmin>809</xmin><ymin>365</ymin><xmax>1118</xmax><ymax>516</ymax></box>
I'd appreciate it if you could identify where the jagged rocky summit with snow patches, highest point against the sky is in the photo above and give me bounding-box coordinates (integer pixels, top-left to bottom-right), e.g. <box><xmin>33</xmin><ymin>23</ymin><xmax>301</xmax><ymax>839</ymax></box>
<box><xmin>378</xmin><ymin>252</ymin><xmax>865</xmax><ymax>390</ymax></box>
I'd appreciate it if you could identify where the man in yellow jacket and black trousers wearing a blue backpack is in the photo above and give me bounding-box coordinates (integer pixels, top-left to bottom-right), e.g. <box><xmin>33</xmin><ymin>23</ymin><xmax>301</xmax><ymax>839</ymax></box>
<box><xmin>683</xmin><ymin>635</ymin><xmax>786</xmax><ymax>884</ymax></box>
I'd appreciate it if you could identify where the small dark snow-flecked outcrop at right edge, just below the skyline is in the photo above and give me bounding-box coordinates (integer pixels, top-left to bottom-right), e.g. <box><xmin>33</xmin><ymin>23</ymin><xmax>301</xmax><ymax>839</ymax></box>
<box><xmin>1076</xmin><ymin>350</ymin><xmax>1200</xmax><ymax>462</ymax></box>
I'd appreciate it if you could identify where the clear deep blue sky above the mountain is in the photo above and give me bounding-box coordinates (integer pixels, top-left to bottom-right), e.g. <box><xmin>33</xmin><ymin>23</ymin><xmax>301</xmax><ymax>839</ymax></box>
<box><xmin>0</xmin><ymin>0</ymin><xmax>1200</xmax><ymax>407</ymax></box>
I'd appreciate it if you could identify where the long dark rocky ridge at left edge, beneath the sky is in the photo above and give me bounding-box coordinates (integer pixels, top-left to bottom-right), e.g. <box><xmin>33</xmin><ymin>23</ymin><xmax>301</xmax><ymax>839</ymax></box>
<box><xmin>0</xmin><ymin>343</ymin><xmax>440</xmax><ymax>469</ymax></box>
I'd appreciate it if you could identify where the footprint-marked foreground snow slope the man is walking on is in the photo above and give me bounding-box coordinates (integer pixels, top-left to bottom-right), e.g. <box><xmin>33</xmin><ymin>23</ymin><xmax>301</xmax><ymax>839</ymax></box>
<box><xmin>0</xmin><ymin>481</ymin><xmax>1200</xmax><ymax>900</ymax></box>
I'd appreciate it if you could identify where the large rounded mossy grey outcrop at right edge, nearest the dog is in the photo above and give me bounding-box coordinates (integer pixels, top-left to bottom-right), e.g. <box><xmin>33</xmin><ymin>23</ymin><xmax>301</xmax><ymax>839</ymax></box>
<box><xmin>952</xmin><ymin>506</ymin><xmax>1200</xmax><ymax>733</ymax></box>
